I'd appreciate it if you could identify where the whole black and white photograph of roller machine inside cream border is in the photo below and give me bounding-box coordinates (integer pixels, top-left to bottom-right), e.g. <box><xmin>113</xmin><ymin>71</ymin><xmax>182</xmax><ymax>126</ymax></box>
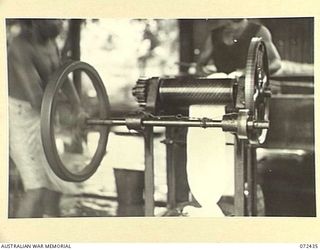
<box><xmin>5</xmin><ymin>16</ymin><xmax>318</xmax><ymax>220</ymax></box>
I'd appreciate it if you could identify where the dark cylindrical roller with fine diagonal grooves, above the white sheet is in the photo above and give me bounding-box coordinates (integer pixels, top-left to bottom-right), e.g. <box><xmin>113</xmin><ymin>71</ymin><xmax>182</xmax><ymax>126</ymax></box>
<box><xmin>159</xmin><ymin>78</ymin><xmax>236</xmax><ymax>106</ymax></box>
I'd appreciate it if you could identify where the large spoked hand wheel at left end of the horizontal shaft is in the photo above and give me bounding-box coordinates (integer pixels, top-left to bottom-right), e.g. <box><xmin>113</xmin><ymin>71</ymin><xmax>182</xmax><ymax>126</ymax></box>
<box><xmin>41</xmin><ymin>61</ymin><xmax>110</xmax><ymax>182</ymax></box>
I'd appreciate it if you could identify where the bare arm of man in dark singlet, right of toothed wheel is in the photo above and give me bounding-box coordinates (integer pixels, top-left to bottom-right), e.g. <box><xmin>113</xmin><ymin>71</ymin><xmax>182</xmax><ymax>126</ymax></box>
<box><xmin>257</xmin><ymin>26</ymin><xmax>281</xmax><ymax>74</ymax></box>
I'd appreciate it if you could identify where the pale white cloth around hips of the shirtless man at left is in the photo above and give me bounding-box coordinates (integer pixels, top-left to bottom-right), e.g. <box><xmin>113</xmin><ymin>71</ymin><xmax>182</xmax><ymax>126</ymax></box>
<box><xmin>9</xmin><ymin>97</ymin><xmax>80</xmax><ymax>194</ymax></box>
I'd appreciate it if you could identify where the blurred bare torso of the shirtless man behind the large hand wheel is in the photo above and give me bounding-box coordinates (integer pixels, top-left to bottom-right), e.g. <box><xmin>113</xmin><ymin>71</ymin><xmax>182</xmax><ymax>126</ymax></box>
<box><xmin>8</xmin><ymin>35</ymin><xmax>59</xmax><ymax>105</ymax></box>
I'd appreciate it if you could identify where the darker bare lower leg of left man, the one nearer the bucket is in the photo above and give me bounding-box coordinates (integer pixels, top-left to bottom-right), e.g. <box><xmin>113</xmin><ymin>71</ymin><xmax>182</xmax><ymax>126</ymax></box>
<box><xmin>42</xmin><ymin>189</ymin><xmax>61</xmax><ymax>218</ymax></box>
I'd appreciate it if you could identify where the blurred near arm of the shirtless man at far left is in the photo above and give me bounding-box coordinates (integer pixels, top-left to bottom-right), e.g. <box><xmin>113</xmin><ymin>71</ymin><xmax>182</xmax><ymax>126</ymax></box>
<box><xmin>8</xmin><ymin>44</ymin><xmax>43</xmax><ymax>112</ymax></box>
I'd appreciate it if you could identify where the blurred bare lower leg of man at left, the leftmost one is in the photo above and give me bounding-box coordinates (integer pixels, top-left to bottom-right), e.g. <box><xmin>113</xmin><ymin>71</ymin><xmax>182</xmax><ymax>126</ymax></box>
<box><xmin>16</xmin><ymin>188</ymin><xmax>44</xmax><ymax>218</ymax></box>
